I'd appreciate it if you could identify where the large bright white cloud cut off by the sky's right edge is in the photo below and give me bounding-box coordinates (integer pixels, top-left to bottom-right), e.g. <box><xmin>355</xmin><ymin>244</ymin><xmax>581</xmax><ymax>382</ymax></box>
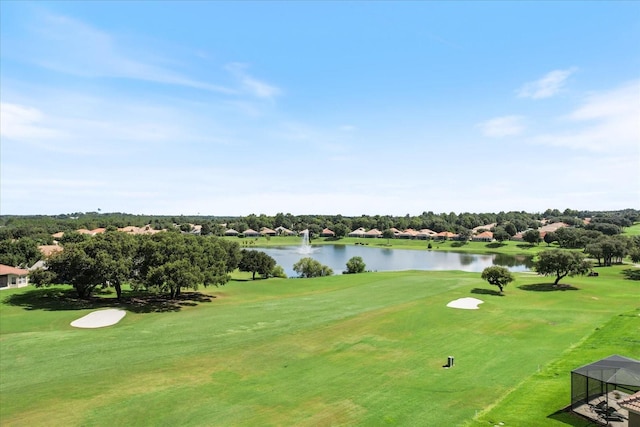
<box><xmin>533</xmin><ymin>81</ymin><xmax>640</xmax><ymax>152</ymax></box>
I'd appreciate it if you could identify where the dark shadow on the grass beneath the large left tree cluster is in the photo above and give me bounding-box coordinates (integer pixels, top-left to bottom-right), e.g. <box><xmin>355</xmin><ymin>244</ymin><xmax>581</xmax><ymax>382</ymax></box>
<box><xmin>3</xmin><ymin>288</ymin><xmax>215</xmax><ymax>313</ymax></box>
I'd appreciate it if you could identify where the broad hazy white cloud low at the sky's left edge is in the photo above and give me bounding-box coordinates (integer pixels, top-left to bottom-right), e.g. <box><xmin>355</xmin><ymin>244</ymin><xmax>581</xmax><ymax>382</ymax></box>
<box><xmin>0</xmin><ymin>85</ymin><xmax>233</xmax><ymax>160</ymax></box>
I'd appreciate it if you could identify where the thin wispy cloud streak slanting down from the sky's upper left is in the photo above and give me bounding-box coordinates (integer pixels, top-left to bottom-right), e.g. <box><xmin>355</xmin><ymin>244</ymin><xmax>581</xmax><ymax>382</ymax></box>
<box><xmin>15</xmin><ymin>13</ymin><xmax>235</xmax><ymax>94</ymax></box>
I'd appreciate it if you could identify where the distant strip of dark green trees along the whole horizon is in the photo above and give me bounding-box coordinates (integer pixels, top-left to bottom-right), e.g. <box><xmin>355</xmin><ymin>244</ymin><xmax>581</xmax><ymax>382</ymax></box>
<box><xmin>0</xmin><ymin>209</ymin><xmax>640</xmax><ymax>244</ymax></box>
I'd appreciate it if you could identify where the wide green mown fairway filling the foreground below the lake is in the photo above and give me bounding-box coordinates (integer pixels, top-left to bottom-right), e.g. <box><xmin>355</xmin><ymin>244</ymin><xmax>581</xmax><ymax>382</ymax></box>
<box><xmin>0</xmin><ymin>267</ymin><xmax>640</xmax><ymax>426</ymax></box>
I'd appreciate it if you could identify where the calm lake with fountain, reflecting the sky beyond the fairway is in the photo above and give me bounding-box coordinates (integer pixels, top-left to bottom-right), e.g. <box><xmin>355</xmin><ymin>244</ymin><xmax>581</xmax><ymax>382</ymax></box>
<box><xmin>255</xmin><ymin>245</ymin><xmax>531</xmax><ymax>277</ymax></box>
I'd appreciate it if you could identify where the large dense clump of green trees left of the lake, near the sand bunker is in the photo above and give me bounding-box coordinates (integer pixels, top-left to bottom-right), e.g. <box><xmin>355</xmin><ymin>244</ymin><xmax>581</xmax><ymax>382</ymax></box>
<box><xmin>32</xmin><ymin>231</ymin><xmax>240</xmax><ymax>298</ymax></box>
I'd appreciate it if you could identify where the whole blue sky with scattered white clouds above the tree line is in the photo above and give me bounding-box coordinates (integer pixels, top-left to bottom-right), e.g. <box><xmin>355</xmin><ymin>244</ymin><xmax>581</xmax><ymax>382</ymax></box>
<box><xmin>0</xmin><ymin>1</ymin><xmax>640</xmax><ymax>215</ymax></box>
